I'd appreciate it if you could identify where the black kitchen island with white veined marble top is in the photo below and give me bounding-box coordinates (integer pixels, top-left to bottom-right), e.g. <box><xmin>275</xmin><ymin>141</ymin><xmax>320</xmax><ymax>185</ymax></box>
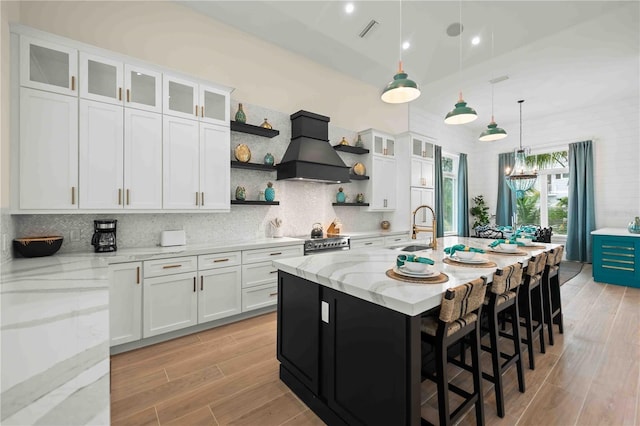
<box><xmin>274</xmin><ymin>237</ymin><xmax>556</xmax><ymax>425</ymax></box>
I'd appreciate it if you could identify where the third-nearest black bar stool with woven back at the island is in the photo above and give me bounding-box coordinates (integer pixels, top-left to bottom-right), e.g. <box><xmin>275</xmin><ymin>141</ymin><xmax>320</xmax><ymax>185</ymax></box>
<box><xmin>518</xmin><ymin>252</ymin><xmax>547</xmax><ymax>370</ymax></box>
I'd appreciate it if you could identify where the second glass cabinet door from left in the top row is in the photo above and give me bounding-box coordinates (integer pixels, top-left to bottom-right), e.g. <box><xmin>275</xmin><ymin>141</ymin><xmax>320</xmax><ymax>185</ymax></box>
<box><xmin>80</xmin><ymin>52</ymin><xmax>124</xmax><ymax>105</ymax></box>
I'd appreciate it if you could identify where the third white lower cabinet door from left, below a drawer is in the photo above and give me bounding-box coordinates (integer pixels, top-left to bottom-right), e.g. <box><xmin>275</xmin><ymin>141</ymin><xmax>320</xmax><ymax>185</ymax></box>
<box><xmin>198</xmin><ymin>266</ymin><xmax>242</xmax><ymax>324</ymax></box>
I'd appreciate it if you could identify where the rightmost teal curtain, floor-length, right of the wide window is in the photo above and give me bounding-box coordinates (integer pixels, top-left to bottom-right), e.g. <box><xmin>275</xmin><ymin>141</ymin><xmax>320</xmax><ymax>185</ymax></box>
<box><xmin>566</xmin><ymin>141</ymin><xmax>596</xmax><ymax>263</ymax></box>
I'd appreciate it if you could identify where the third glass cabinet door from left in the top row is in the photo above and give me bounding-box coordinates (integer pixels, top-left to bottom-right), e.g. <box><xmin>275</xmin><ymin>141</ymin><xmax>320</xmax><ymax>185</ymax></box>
<box><xmin>124</xmin><ymin>64</ymin><xmax>162</xmax><ymax>112</ymax></box>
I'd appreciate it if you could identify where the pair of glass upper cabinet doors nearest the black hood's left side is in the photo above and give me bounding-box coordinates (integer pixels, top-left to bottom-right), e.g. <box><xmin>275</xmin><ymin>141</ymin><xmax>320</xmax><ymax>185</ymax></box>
<box><xmin>163</xmin><ymin>74</ymin><xmax>230</xmax><ymax>127</ymax></box>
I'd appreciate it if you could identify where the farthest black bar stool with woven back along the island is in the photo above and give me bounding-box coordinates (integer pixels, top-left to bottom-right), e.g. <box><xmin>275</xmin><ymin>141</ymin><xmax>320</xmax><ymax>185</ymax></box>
<box><xmin>542</xmin><ymin>246</ymin><xmax>564</xmax><ymax>345</ymax></box>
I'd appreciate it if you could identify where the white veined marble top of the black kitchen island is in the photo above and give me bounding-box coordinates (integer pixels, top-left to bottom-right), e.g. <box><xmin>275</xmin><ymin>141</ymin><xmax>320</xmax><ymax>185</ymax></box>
<box><xmin>273</xmin><ymin>237</ymin><xmax>557</xmax><ymax>316</ymax></box>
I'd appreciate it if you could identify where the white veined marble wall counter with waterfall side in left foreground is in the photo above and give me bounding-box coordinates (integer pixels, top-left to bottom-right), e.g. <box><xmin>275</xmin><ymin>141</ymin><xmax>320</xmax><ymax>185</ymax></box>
<box><xmin>0</xmin><ymin>238</ymin><xmax>303</xmax><ymax>426</ymax></box>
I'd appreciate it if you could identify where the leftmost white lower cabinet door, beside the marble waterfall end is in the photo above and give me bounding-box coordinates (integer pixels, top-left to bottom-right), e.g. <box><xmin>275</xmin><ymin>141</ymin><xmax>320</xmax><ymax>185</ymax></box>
<box><xmin>109</xmin><ymin>262</ymin><xmax>142</xmax><ymax>346</ymax></box>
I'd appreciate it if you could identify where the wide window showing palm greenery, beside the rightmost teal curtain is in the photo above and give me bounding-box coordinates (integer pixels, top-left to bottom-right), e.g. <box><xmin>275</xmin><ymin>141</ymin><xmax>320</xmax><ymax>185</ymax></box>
<box><xmin>516</xmin><ymin>151</ymin><xmax>569</xmax><ymax>235</ymax></box>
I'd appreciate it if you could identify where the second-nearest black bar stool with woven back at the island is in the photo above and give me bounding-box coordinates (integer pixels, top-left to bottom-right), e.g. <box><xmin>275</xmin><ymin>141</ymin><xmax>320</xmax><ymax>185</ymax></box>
<box><xmin>480</xmin><ymin>262</ymin><xmax>525</xmax><ymax>417</ymax></box>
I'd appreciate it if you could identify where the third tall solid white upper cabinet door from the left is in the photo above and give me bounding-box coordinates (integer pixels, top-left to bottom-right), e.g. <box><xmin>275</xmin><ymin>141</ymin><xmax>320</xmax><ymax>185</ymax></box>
<box><xmin>123</xmin><ymin>108</ymin><xmax>162</xmax><ymax>209</ymax></box>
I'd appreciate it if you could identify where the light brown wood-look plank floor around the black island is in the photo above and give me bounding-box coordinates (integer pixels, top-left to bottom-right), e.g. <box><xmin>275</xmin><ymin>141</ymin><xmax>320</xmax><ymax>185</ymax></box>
<box><xmin>111</xmin><ymin>265</ymin><xmax>640</xmax><ymax>426</ymax></box>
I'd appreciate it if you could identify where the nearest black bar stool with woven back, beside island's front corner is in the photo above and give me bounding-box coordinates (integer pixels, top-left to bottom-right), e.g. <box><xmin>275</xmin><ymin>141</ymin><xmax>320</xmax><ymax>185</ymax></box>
<box><xmin>420</xmin><ymin>278</ymin><xmax>487</xmax><ymax>426</ymax></box>
